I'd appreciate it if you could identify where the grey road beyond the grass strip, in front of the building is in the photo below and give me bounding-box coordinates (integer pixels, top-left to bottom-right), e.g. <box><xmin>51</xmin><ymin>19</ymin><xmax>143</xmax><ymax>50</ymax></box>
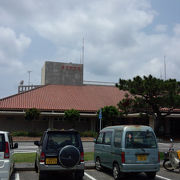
<box><xmin>15</xmin><ymin>142</ymin><xmax>180</xmax><ymax>152</ymax></box>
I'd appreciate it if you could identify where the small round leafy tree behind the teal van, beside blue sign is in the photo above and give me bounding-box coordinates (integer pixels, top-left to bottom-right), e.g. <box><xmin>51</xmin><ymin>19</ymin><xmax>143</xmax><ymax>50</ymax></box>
<box><xmin>98</xmin><ymin>106</ymin><xmax>119</xmax><ymax>127</ymax></box>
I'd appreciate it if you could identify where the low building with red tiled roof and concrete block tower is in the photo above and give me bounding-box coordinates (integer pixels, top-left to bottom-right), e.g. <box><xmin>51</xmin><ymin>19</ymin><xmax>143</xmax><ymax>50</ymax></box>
<box><xmin>0</xmin><ymin>61</ymin><xmax>180</xmax><ymax>136</ymax></box>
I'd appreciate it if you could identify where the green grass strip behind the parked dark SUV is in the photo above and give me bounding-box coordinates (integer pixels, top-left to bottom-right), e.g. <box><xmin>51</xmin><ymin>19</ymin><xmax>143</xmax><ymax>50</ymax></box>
<box><xmin>14</xmin><ymin>152</ymin><xmax>94</xmax><ymax>163</ymax></box>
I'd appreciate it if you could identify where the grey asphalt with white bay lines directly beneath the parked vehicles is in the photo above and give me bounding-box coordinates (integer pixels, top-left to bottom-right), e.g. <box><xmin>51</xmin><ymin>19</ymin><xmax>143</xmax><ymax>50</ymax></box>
<box><xmin>11</xmin><ymin>169</ymin><xmax>180</xmax><ymax>180</ymax></box>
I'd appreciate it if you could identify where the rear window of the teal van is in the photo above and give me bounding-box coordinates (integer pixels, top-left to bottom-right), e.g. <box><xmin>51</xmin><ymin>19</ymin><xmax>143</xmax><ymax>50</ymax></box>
<box><xmin>125</xmin><ymin>131</ymin><xmax>157</xmax><ymax>149</ymax></box>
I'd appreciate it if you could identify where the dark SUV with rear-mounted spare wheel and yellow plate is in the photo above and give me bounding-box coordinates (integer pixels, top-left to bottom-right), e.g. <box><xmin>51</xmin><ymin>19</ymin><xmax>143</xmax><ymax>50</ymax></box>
<box><xmin>34</xmin><ymin>130</ymin><xmax>84</xmax><ymax>180</ymax></box>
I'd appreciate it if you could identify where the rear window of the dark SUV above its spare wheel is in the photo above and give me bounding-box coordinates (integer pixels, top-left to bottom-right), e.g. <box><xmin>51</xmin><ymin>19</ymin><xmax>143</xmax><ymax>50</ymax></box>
<box><xmin>47</xmin><ymin>132</ymin><xmax>79</xmax><ymax>149</ymax></box>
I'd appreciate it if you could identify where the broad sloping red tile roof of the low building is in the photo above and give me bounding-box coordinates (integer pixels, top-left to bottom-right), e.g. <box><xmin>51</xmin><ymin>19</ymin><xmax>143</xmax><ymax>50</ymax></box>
<box><xmin>0</xmin><ymin>85</ymin><xmax>126</xmax><ymax>112</ymax></box>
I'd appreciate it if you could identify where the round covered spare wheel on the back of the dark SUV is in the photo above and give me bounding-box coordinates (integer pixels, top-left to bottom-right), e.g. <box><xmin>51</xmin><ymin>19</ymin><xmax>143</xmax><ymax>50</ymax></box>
<box><xmin>59</xmin><ymin>145</ymin><xmax>80</xmax><ymax>168</ymax></box>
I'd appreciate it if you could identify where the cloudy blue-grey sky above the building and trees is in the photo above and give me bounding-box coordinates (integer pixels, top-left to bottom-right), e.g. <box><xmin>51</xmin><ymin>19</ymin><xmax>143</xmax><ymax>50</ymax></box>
<box><xmin>0</xmin><ymin>0</ymin><xmax>180</xmax><ymax>98</ymax></box>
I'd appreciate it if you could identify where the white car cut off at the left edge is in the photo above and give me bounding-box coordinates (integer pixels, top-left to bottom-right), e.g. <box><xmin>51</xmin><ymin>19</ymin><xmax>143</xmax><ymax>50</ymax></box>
<box><xmin>0</xmin><ymin>131</ymin><xmax>18</xmax><ymax>180</ymax></box>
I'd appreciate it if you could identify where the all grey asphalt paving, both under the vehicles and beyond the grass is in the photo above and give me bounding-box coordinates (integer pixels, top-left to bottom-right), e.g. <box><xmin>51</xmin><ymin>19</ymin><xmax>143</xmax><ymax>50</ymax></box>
<box><xmin>11</xmin><ymin>142</ymin><xmax>180</xmax><ymax>180</ymax></box>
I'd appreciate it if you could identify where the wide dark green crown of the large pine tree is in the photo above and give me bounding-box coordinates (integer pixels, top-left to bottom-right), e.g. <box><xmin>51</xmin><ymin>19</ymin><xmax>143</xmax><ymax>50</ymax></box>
<box><xmin>117</xmin><ymin>75</ymin><xmax>180</xmax><ymax>113</ymax></box>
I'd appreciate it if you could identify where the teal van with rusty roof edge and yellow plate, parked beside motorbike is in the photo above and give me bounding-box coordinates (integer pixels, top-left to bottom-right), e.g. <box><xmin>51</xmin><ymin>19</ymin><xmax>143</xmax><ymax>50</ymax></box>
<box><xmin>94</xmin><ymin>125</ymin><xmax>160</xmax><ymax>180</ymax></box>
